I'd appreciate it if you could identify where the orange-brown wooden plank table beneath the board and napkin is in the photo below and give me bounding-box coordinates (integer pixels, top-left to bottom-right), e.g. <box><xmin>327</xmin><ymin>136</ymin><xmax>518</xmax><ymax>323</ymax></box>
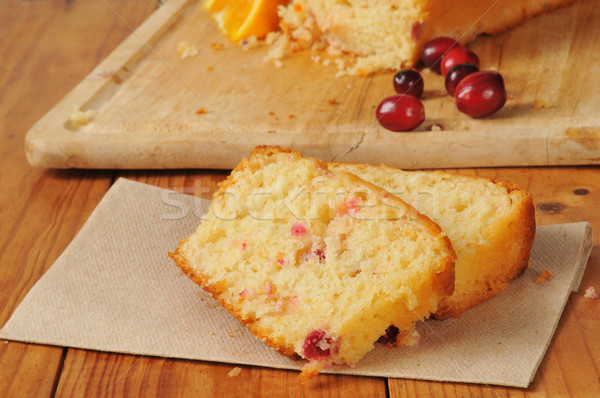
<box><xmin>0</xmin><ymin>0</ymin><xmax>600</xmax><ymax>397</ymax></box>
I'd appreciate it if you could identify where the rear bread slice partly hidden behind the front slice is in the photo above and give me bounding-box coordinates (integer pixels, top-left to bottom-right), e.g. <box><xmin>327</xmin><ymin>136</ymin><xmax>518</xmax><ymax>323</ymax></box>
<box><xmin>328</xmin><ymin>163</ymin><xmax>535</xmax><ymax>319</ymax></box>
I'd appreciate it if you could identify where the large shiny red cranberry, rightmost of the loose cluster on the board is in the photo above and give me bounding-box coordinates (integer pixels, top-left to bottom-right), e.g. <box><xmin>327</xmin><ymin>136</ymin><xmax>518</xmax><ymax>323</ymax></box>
<box><xmin>454</xmin><ymin>71</ymin><xmax>506</xmax><ymax>117</ymax></box>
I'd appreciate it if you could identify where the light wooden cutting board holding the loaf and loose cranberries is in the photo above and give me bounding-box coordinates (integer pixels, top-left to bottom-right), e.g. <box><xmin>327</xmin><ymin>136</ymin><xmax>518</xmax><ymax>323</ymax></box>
<box><xmin>26</xmin><ymin>0</ymin><xmax>600</xmax><ymax>169</ymax></box>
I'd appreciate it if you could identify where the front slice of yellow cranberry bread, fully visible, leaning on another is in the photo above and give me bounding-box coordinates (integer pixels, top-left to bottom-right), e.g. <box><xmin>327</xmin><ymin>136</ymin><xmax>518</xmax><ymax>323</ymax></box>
<box><xmin>172</xmin><ymin>147</ymin><xmax>455</xmax><ymax>370</ymax></box>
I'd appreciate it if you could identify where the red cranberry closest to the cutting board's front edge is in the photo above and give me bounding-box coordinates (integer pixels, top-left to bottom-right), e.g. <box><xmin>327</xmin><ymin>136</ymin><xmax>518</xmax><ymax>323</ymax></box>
<box><xmin>375</xmin><ymin>94</ymin><xmax>425</xmax><ymax>131</ymax></box>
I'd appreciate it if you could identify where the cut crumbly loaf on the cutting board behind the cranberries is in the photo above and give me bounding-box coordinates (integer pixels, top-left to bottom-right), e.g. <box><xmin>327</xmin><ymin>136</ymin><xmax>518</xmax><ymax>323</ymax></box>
<box><xmin>272</xmin><ymin>0</ymin><xmax>573</xmax><ymax>75</ymax></box>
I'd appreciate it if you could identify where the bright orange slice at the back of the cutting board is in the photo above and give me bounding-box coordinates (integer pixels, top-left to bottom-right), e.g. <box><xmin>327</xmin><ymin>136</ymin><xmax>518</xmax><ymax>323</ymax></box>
<box><xmin>204</xmin><ymin>0</ymin><xmax>289</xmax><ymax>41</ymax></box>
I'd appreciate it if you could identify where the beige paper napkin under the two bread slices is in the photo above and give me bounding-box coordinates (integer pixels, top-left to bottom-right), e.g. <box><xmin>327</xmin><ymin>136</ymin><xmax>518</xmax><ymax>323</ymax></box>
<box><xmin>0</xmin><ymin>179</ymin><xmax>592</xmax><ymax>387</ymax></box>
